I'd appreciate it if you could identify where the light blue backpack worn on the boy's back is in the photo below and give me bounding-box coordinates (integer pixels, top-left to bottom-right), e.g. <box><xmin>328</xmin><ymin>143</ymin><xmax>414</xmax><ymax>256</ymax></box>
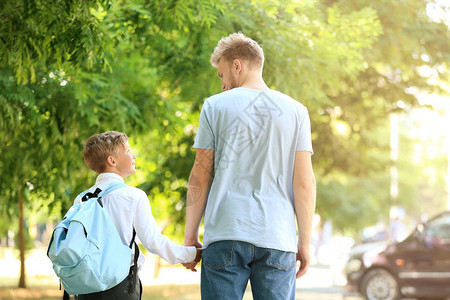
<box><xmin>47</xmin><ymin>183</ymin><xmax>137</xmax><ymax>295</ymax></box>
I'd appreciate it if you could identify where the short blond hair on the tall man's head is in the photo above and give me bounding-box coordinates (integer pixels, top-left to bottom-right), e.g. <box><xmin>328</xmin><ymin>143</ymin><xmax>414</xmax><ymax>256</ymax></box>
<box><xmin>210</xmin><ymin>32</ymin><xmax>264</xmax><ymax>69</ymax></box>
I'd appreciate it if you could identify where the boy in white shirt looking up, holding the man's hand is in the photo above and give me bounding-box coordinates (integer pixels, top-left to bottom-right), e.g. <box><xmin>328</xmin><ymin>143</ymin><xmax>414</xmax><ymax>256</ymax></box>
<box><xmin>75</xmin><ymin>131</ymin><xmax>201</xmax><ymax>300</ymax></box>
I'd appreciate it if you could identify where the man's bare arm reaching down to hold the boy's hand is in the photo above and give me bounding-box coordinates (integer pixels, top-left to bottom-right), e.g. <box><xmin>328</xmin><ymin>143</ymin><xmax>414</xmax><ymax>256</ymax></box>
<box><xmin>184</xmin><ymin>149</ymin><xmax>214</xmax><ymax>270</ymax></box>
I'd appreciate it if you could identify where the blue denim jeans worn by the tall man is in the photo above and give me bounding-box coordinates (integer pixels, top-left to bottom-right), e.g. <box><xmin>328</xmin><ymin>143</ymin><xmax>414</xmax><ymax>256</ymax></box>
<box><xmin>201</xmin><ymin>241</ymin><xmax>296</xmax><ymax>300</ymax></box>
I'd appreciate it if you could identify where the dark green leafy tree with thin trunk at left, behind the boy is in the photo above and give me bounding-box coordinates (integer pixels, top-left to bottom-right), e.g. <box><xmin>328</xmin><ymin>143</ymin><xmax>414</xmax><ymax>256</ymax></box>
<box><xmin>0</xmin><ymin>1</ymin><xmax>223</xmax><ymax>287</ymax></box>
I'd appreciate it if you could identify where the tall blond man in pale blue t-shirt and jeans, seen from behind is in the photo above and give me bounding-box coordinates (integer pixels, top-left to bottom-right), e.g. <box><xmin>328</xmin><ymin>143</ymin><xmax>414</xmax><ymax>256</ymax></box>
<box><xmin>185</xmin><ymin>33</ymin><xmax>315</xmax><ymax>300</ymax></box>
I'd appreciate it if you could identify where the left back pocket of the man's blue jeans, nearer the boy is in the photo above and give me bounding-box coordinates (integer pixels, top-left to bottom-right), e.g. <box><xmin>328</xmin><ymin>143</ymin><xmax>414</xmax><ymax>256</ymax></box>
<box><xmin>202</xmin><ymin>241</ymin><xmax>235</xmax><ymax>270</ymax></box>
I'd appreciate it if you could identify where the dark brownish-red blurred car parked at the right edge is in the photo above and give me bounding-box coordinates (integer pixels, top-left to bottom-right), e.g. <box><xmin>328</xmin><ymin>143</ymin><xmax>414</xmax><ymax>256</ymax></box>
<box><xmin>345</xmin><ymin>211</ymin><xmax>450</xmax><ymax>300</ymax></box>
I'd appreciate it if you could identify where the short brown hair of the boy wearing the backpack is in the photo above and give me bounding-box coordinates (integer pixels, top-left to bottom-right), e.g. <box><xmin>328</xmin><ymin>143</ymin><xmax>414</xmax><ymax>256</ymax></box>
<box><xmin>83</xmin><ymin>131</ymin><xmax>128</xmax><ymax>173</ymax></box>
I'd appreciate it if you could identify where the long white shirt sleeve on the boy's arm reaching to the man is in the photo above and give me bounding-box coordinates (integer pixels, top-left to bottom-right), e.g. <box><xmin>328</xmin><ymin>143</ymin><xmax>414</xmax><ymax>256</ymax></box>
<box><xmin>134</xmin><ymin>192</ymin><xmax>197</xmax><ymax>264</ymax></box>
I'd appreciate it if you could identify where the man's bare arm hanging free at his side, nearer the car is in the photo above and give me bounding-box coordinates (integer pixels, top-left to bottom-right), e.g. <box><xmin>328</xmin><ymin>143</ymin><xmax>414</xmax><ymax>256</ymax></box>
<box><xmin>293</xmin><ymin>151</ymin><xmax>316</xmax><ymax>278</ymax></box>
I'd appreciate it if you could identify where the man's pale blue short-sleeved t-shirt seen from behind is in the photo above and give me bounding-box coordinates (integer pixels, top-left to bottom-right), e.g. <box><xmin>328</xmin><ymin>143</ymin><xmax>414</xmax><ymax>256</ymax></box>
<box><xmin>194</xmin><ymin>87</ymin><xmax>313</xmax><ymax>252</ymax></box>
